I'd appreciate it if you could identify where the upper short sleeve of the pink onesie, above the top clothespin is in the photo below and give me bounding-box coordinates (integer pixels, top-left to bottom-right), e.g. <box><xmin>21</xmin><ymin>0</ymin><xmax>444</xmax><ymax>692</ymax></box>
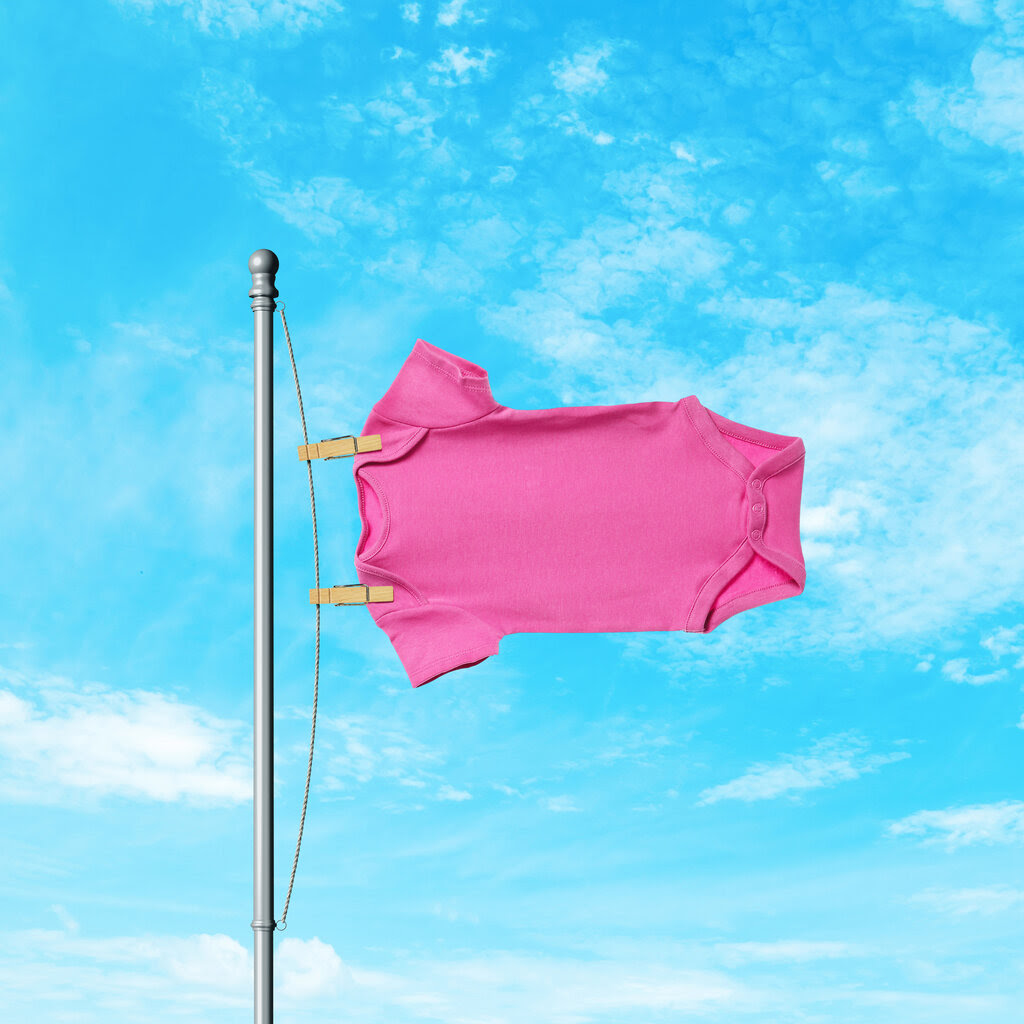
<box><xmin>374</xmin><ymin>338</ymin><xmax>503</xmax><ymax>427</ymax></box>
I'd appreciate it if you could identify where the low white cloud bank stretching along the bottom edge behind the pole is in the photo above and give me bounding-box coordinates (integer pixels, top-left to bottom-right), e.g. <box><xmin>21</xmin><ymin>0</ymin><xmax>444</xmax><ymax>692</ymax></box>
<box><xmin>0</xmin><ymin>921</ymin><xmax>1013</xmax><ymax>1024</ymax></box>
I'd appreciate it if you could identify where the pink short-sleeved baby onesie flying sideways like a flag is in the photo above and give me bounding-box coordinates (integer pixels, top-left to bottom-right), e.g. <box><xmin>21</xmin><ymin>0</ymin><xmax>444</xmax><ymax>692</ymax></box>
<box><xmin>352</xmin><ymin>338</ymin><xmax>805</xmax><ymax>686</ymax></box>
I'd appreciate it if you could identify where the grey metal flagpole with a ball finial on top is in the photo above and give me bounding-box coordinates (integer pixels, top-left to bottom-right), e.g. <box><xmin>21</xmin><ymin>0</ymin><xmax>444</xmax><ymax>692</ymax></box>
<box><xmin>249</xmin><ymin>249</ymin><xmax>280</xmax><ymax>1024</ymax></box>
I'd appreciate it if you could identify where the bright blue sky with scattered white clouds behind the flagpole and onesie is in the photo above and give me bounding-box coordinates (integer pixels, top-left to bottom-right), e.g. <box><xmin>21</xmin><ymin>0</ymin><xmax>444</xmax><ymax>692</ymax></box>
<box><xmin>0</xmin><ymin>0</ymin><xmax>1024</xmax><ymax>1024</ymax></box>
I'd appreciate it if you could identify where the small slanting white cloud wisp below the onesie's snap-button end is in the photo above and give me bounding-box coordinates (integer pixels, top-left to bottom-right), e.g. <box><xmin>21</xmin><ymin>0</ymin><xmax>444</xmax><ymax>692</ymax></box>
<box><xmin>697</xmin><ymin>732</ymin><xmax>910</xmax><ymax>806</ymax></box>
